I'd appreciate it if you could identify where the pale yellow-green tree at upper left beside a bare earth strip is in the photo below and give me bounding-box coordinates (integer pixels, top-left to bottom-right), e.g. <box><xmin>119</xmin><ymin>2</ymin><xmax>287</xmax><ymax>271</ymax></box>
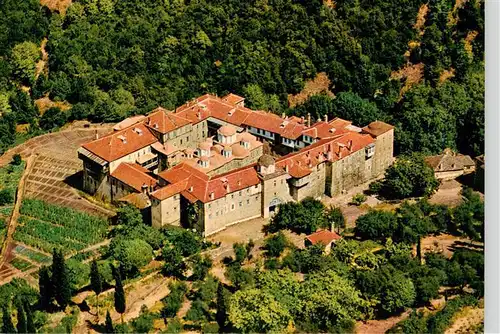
<box><xmin>11</xmin><ymin>42</ymin><xmax>41</xmax><ymax>86</ymax></box>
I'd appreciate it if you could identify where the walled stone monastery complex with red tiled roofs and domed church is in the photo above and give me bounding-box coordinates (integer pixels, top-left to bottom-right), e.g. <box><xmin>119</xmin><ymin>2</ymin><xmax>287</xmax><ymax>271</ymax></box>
<box><xmin>78</xmin><ymin>94</ymin><xmax>394</xmax><ymax>236</ymax></box>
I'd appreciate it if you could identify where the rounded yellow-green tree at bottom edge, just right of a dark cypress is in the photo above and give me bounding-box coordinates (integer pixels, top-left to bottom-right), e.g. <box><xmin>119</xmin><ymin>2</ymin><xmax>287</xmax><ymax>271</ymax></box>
<box><xmin>228</xmin><ymin>289</ymin><xmax>293</xmax><ymax>333</ymax></box>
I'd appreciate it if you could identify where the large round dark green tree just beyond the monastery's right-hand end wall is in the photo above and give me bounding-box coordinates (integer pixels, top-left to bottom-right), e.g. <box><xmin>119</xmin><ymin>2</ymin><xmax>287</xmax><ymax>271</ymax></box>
<box><xmin>381</xmin><ymin>154</ymin><xmax>439</xmax><ymax>199</ymax></box>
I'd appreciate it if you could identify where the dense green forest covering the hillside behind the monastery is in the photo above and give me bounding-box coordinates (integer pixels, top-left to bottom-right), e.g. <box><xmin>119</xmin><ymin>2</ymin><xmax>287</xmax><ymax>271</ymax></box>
<box><xmin>0</xmin><ymin>0</ymin><xmax>484</xmax><ymax>155</ymax></box>
